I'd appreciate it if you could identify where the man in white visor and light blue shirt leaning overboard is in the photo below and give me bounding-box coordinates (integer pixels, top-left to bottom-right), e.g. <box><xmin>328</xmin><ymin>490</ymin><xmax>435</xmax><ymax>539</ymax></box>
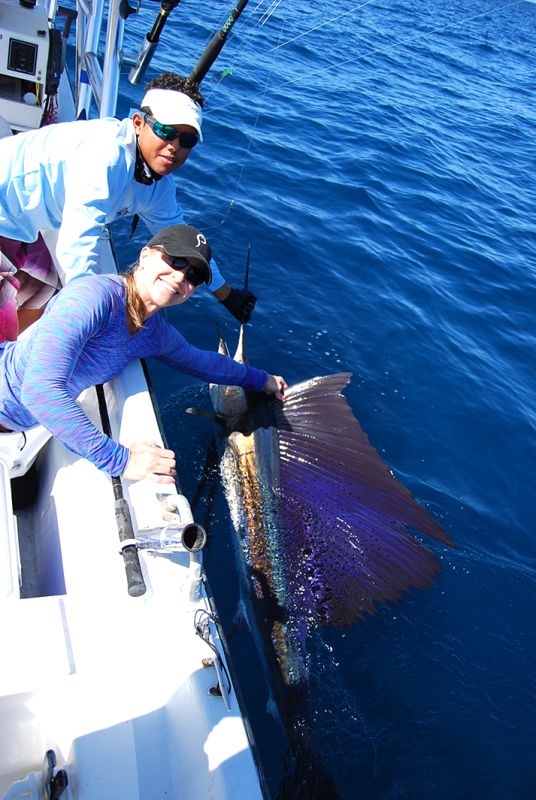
<box><xmin>0</xmin><ymin>73</ymin><xmax>256</xmax><ymax>340</ymax></box>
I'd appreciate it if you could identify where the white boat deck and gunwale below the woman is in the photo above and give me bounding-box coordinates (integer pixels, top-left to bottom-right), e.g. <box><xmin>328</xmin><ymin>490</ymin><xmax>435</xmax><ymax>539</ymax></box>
<box><xmin>0</xmin><ymin>380</ymin><xmax>262</xmax><ymax>800</ymax></box>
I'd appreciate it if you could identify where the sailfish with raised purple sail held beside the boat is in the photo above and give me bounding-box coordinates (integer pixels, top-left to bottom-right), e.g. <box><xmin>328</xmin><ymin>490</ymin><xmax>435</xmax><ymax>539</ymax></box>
<box><xmin>193</xmin><ymin>325</ymin><xmax>453</xmax><ymax>686</ymax></box>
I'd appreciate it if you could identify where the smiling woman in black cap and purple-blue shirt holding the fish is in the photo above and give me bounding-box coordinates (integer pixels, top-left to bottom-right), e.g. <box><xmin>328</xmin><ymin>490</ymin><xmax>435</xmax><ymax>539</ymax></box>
<box><xmin>0</xmin><ymin>225</ymin><xmax>287</xmax><ymax>483</ymax></box>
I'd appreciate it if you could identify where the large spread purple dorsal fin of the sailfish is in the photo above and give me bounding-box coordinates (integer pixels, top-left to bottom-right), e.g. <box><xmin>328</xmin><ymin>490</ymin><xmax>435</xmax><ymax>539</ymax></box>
<box><xmin>270</xmin><ymin>373</ymin><xmax>452</xmax><ymax>625</ymax></box>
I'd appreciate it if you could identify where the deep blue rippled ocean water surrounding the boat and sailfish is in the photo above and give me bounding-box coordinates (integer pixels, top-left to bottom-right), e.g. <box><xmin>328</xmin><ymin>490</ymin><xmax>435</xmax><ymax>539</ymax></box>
<box><xmin>111</xmin><ymin>0</ymin><xmax>536</xmax><ymax>800</ymax></box>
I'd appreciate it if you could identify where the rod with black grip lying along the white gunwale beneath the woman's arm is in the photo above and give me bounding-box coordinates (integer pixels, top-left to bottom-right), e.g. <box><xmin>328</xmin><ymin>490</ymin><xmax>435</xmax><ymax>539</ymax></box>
<box><xmin>95</xmin><ymin>384</ymin><xmax>147</xmax><ymax>597</ymax></box>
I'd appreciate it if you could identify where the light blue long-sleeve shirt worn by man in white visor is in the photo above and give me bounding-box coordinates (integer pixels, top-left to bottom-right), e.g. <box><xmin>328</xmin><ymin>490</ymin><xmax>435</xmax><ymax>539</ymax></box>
<box><xmin>0</xmin><ymin>117</ymin><xmax>225</xmax><ymax>292</ymax></box>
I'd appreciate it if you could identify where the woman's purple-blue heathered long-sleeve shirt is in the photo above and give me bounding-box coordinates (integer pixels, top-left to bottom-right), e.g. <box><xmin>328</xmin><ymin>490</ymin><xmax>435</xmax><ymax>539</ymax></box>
<box><xmin>0</xmin><ymin>275</ymin><xmax>268</xmax><ymax>475</ymax></box>
